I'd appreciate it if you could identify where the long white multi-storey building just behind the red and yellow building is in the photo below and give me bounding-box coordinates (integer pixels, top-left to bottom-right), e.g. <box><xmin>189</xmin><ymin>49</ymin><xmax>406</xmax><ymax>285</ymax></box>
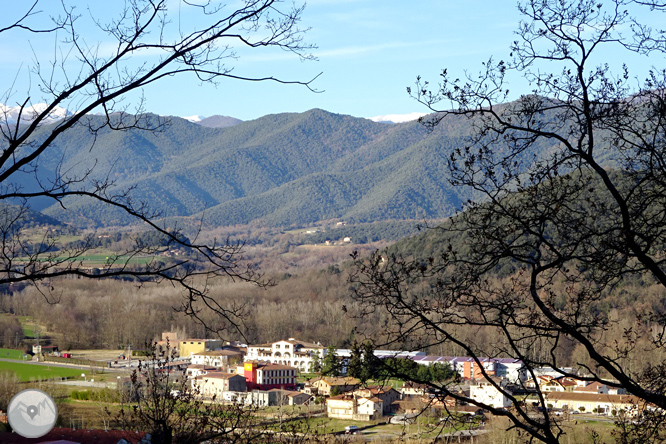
<box><xmin>245</xmin><ymin>338</ymin><xmax>326</xmax><ymax>372</ymax></box>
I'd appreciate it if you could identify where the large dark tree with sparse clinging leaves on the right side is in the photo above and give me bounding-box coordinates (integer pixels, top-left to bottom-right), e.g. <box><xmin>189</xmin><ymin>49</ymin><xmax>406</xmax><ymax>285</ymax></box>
<box><xmin>353</xmin><ymin>0</ymin><xmax>666</xmax><ymax>443</ymax></box>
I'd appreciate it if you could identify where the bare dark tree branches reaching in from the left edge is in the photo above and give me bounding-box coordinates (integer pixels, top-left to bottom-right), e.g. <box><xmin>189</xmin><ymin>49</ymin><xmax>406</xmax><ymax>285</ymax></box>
<box><xmin>0</xmin><ymin>0</ymin><xmax>313</xmax><ymax>336</ymax></box>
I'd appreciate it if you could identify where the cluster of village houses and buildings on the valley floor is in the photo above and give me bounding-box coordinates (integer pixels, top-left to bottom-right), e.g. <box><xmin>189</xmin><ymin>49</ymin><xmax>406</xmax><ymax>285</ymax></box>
<box><xmin>156</xmin><ymin>333</ymin><xmax>642</xmax><ymax>421</ymax></box>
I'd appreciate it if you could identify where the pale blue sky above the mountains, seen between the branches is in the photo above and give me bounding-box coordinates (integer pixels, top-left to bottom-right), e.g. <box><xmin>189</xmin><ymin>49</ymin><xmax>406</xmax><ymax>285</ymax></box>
<box><xmin>0</xmin><ymin>0</ymin><xmax>660</xmax><ymax>120</ymax></box>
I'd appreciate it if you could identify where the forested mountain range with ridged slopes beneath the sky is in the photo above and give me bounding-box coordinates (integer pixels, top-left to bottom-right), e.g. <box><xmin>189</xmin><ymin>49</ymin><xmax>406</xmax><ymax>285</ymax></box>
<box><xmin>15</xmin><ymin>109</ymin><xmax>548</xmax><ymax>227</ymax></box>
